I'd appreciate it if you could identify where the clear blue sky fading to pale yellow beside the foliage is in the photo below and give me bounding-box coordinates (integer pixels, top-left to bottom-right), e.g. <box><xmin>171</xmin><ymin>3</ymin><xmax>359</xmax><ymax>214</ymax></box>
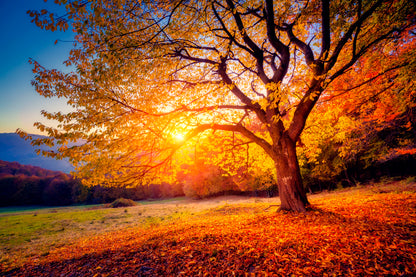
<box><xmin>0</xmin><ymin>0</ymin><xmax>73</xmax><ymax>133</ymax></box>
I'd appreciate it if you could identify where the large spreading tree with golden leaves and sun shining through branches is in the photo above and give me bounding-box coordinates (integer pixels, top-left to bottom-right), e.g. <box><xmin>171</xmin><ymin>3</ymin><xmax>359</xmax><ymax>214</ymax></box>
<box><xmin>23</xmin><ymin>0</ymin><xmax>416</xmax><ymax>211</ymax></box>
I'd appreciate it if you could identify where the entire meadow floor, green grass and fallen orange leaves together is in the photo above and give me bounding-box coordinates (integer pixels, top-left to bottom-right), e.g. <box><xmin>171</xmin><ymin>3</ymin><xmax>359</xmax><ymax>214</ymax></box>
<box><xmin>0</xmin><ymin>179</ymin><xmax>416</xmax><ymax>276</ymax></box>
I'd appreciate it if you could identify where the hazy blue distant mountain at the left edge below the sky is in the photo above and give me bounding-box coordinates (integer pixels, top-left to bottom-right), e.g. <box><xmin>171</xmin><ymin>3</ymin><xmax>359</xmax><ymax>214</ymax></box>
<box><xmin>0</xmin><ymin>133</ymin><xmax>73</xmax><ymax>173</ymax></box>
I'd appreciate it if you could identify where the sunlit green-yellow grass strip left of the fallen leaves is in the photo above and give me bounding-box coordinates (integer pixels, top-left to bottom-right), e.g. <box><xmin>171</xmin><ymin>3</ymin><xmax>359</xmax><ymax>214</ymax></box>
<box><xmin>0</xmin><ymin>199</ymin><xmax>201</xmax><ymax>271</ymax></box>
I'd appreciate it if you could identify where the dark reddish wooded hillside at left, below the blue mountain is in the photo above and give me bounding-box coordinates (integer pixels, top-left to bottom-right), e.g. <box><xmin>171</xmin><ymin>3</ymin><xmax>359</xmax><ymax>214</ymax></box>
<box><xmin>0</xmin><ymin>160</ymin><xmax>174</xmax><ymax>206</ymax></box>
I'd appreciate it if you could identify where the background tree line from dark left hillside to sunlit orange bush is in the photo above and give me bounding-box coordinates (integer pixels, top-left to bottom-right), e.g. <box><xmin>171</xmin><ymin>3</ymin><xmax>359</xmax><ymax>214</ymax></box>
<box><xmin>0</xmin><ymin>158</ymin><xmax>276</xmax><ymax>206</ymax></box>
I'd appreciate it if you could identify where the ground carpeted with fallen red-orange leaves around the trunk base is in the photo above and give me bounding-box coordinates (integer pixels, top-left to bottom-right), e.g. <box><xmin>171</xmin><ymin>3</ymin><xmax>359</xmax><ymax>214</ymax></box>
<box><xmin>3</xmin><ymin>181</ymin><xmax>416</xmax><ymax>276</ymax></box>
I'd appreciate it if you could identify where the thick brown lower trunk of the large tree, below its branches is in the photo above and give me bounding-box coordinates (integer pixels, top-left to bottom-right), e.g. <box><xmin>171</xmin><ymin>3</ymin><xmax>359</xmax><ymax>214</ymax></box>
<box><xmin>275</xmin><ymin>136</ymin><xmax>309</xmax><ymax>212</ymax></box>
